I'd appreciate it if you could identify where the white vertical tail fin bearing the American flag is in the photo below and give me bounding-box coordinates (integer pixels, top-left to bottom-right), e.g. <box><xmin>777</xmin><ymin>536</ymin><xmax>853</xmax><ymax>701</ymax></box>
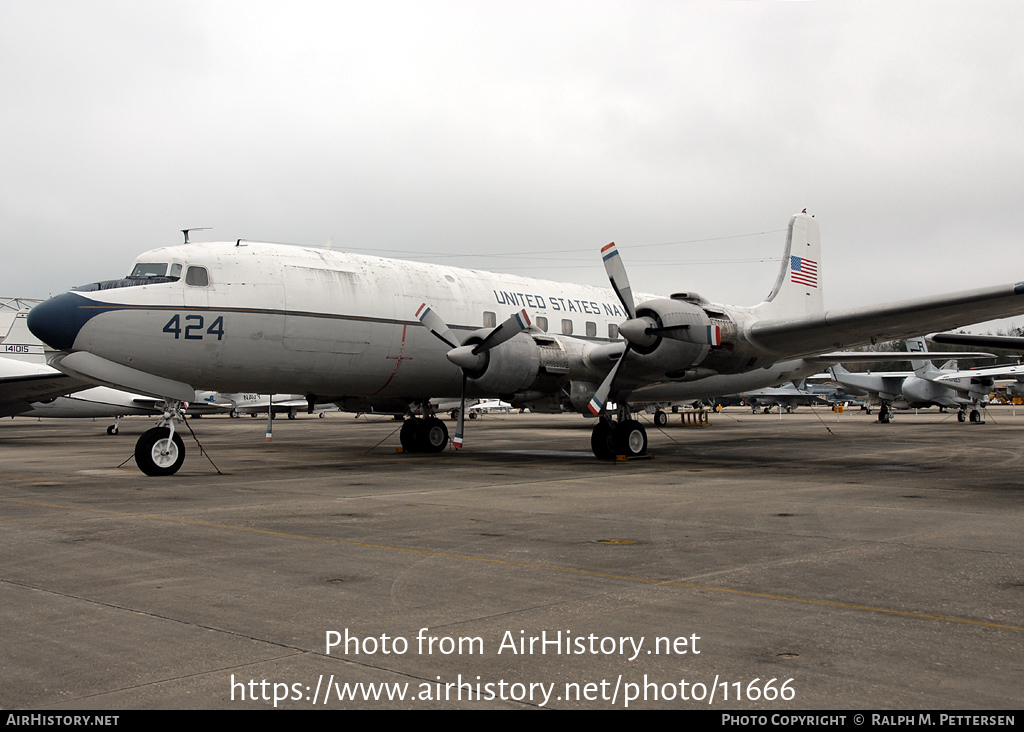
<box><xmin>757</xmin><ymin>213</ymin><xmax>824</xmax><ymax>318</ymax></box>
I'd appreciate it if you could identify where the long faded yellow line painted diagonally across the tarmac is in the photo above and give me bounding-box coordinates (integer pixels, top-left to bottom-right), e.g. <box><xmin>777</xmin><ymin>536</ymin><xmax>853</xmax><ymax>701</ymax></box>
<box><xmin>8</xmin><ymin>499</ymin><xmax>1024</xmax><ymax>632</ymax></box>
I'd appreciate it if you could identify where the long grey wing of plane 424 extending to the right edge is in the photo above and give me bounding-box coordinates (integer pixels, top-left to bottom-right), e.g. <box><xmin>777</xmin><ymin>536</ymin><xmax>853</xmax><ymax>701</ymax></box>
<box><xmin>750</xmin><ymin>283</ymin><xmax>1024</xmax><ymax>358</ymax></box>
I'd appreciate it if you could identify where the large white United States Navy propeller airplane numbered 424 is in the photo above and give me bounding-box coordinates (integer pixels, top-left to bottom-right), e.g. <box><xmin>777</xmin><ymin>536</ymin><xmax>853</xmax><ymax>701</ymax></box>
<box><xmin>29</xmin><ymin>213</ymin><xmax>1024</xmax><ymax>475</ymax></box>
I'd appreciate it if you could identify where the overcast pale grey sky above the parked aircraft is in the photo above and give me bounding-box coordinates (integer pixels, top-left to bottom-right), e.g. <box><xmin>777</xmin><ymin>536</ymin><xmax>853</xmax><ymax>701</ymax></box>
<box><xmin>0</xmin><ymin>0</ymin><xmax>1024</xmax><ymax>329</ymax></box>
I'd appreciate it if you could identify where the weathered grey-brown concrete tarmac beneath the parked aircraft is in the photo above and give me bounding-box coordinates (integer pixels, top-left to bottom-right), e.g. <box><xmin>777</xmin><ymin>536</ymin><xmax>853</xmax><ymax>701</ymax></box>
<box><xmin>0</xmin><ymin>407</ymin><xmax>1024</xmax><ymax>713</ymax></box>
